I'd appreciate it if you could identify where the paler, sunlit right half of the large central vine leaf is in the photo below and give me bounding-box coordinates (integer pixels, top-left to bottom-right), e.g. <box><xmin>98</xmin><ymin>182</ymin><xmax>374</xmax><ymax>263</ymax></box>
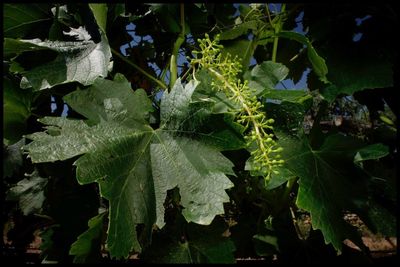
<box><xmin>151</xmin><ymin>79</ymin><xmax>234</xmax><ymax>226</ymax></box>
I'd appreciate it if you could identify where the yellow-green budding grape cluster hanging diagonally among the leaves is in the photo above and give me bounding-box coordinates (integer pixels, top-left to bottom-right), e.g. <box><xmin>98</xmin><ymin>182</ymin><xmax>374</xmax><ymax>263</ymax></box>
<box><xmin>191</xmin><ymin>34</ymin><xmax>284</xmax><ymax>183</ymax></box>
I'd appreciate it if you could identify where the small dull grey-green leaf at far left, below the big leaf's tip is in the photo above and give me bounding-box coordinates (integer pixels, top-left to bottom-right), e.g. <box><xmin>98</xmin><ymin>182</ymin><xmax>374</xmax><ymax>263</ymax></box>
<box><xmin>7</xmin><ymin>170</ymin><xmax>47</xmax><ymax>215</ymax></box>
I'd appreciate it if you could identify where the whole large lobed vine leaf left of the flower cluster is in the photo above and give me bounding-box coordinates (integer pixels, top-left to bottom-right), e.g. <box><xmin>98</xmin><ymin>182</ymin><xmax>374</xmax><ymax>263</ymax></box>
<box><xmin>25</xmin><ymin>75</ymin><xmax>239</xmax><ymax>258</ymax></box>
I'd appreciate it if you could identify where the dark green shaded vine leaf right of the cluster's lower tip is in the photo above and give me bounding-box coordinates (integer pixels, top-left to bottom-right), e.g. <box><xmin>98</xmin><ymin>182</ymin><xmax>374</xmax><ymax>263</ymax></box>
<box><xmin>280</xmin><ymin>134</ymin><xmax>392</xmax><ymax>251</ymax></box>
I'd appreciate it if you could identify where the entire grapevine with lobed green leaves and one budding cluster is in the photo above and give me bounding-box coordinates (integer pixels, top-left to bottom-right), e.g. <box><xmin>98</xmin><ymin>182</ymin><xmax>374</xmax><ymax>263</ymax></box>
<box><xmin>3</xmin><ymin>4</ymin><xmax>397</xmax><ymax>263</ymax></box>
